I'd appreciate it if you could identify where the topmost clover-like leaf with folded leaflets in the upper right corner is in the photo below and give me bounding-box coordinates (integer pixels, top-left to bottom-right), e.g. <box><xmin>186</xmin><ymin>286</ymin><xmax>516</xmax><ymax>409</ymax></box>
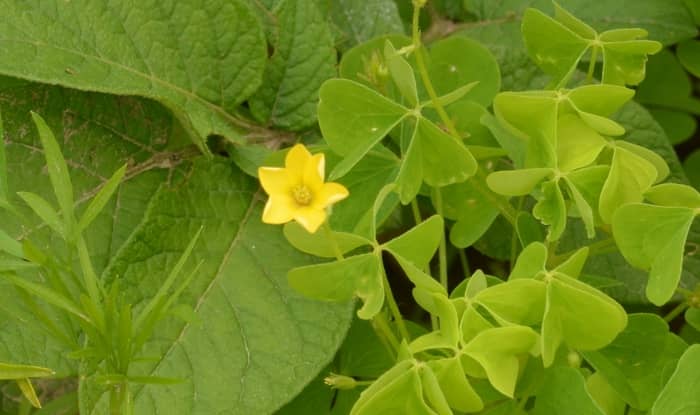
<box><xmin>522</xmin><ymin>3</ymin><xmax>661</xmax><ymax>87</ymax></box>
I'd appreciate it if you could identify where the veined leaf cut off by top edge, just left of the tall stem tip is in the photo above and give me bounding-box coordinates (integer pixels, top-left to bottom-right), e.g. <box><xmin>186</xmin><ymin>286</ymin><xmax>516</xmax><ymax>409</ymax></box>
<box><xmin>329</xmin><ymin>0</ymin><xmax>404</xmax><ymax>51</ymax></box>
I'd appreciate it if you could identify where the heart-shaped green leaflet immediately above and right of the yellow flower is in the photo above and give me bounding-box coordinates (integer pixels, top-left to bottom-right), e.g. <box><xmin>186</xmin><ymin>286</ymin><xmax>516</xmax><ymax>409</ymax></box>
<box><xmin>318</xmin><ymin>79</ymin><xmax>408</xmax><ymax>180</ymax></box>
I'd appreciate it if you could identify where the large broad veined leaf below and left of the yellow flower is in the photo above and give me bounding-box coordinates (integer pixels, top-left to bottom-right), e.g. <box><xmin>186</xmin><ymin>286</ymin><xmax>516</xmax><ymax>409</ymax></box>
<box><xmin>80</xmin><ymin>158</ymin><xmax>352</xmax><ymax>414</ymax></box>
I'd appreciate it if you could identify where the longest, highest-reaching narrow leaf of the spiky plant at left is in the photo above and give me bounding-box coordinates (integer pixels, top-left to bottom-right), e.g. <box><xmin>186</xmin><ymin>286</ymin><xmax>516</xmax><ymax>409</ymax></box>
<box><xmin>32</xmin><ymin>112</ymin><xmax>75</xmax><ymax>234</ymax></box>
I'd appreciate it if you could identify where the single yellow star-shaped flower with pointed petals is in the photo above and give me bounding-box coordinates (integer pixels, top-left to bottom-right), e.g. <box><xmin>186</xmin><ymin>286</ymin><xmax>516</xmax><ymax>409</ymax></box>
<box><xmin>258</xmin><ymin>144</ymin><xmax>348</xmax><ymax>233</ymax></box>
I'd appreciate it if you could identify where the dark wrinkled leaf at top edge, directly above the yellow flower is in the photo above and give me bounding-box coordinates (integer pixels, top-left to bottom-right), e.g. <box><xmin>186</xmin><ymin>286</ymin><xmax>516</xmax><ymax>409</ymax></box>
<box><xmin>249</xmin><ymin>0</ymin><xmax>336</xmax><ymax>131</ymax></box>
